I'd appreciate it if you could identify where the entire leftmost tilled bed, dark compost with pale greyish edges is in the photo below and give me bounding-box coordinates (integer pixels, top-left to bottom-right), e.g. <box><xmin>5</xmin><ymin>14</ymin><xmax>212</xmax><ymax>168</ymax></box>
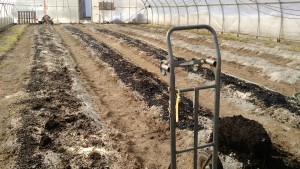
<box><xmin>0</xmin><ymin>26</ymin><xmax>141</xmax><ymax>168</ymax></box>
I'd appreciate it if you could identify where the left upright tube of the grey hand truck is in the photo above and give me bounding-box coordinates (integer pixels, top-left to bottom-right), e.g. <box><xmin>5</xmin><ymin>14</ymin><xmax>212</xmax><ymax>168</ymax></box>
<box><xmin>167</xmin><ymin>30</ymin><xmax>176</xmax><ymax>169</ymax></box>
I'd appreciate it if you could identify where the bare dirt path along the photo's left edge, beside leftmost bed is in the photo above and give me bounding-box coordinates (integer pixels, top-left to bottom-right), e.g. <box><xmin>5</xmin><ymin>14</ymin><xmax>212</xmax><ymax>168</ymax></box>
<box><xmin>0</xmin><ymin>27</ymin><xmax>33</xmax><ymax>168</ymax></box>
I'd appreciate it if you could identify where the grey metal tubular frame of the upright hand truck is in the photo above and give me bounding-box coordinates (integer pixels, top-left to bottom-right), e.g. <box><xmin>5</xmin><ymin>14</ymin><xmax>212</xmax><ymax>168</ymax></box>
<box><xmin>165</xmin><ymin>25</ymin><xmax>221</xmax><ymax>169</ymax></box>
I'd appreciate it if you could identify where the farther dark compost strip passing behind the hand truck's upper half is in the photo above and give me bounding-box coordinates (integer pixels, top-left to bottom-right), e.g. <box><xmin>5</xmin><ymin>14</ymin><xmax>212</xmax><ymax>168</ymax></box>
<box><xmin>96</xmin><ymin>28</ymin><xmax>300</xmax><ymax>115</ymax></box>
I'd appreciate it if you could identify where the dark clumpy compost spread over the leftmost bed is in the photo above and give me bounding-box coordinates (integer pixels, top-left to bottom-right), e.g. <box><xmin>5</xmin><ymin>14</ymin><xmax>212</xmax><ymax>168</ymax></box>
<box><xmin>16</xmin><ymin>25</ymin><xmax>107</xmax><ymax>169</ymax></box>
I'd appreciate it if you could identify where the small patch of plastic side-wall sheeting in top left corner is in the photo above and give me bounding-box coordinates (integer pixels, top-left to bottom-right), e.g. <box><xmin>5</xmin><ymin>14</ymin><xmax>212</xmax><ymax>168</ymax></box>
<box><xmin>0</xmin><ymin>0</ymin><xmax>14</xmax><ymax>31</ymax></box>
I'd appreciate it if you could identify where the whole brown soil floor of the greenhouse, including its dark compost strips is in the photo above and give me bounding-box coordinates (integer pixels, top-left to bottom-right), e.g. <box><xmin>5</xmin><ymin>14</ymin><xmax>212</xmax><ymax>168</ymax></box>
<box><xmin>0</xmin><ymin>24</ymin><xmax>300</xmax><ymax>168</ymax></box>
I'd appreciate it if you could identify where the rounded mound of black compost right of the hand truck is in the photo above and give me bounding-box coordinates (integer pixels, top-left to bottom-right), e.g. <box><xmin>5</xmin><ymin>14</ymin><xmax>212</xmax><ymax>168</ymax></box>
<box><xmin>214</xmin><ymin>115</ymin><xmax>272</xmax><ymax>168</ymax></box>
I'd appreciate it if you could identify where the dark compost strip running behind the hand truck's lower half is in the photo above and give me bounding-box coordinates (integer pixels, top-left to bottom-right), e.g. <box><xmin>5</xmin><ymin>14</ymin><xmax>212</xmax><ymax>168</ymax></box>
<box><xmin>65</xmin><ymin>27</ymin><xmax>212</xmax><ymax>129</ymax></box>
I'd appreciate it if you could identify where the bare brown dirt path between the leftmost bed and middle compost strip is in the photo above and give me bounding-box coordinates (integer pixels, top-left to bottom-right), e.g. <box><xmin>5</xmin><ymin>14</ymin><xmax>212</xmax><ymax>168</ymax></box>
<box><xmin>55</xmin><ymin>24</ymin><xmax>175</xmax><ymax>168</ymax></box>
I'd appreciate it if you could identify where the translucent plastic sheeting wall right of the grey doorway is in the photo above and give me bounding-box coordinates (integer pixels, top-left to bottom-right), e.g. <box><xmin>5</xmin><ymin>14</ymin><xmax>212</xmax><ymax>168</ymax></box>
<box><xmin>92</xmin><ymin>0</ymin><xmax>300</xmax><ymax>40</ymax></box>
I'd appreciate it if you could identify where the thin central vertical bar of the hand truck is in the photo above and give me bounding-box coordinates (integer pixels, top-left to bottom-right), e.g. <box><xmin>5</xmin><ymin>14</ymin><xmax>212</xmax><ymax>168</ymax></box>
<box><xmin>194</xmin><ymin>89</ymin><xmax>199</xmax><ymax>169</ymax></box>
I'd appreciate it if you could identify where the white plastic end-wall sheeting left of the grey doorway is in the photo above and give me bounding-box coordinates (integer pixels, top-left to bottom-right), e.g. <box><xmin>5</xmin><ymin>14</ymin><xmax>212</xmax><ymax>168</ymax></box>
<box><xmin>15</xmin><ymin>0</ymin><xmax>79</xmax><ymax>23</ymax></box>
